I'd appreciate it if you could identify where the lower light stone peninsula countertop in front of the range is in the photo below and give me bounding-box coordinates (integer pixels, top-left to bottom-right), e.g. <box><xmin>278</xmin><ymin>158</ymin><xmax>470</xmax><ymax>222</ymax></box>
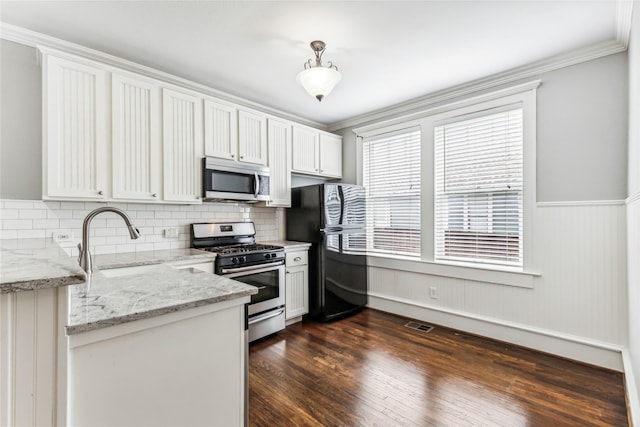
<box><xmin>66</xmin><ymin>264</ymin><xmax>258</xmax><ymax>335</ymax></box>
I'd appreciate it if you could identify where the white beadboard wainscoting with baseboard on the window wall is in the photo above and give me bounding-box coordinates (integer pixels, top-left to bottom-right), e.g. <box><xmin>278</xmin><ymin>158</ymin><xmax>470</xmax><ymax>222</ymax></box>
<box><xmin>369</xmin><ymin>201</ymin><xmax>627</xmax><ymax>371</ymax></box>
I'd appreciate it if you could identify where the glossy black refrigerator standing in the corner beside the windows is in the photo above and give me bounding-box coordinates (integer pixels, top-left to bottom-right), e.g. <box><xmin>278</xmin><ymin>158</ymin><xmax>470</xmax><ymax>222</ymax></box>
<box><xmin>286</xmin><ymin>184</ymin><xmax>367</xmax><ymax>322</ymax></box>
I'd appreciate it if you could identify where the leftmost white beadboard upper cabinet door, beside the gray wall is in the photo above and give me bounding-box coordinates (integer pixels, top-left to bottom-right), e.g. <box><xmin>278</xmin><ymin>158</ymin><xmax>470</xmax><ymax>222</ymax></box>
<box><xmin>43</xmin><ymin>55</ymin><xmax>109</xmax><ymax>200</ymax></box>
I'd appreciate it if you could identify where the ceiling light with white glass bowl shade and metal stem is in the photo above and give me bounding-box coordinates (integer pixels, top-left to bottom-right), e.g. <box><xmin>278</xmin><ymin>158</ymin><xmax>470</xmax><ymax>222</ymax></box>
<box><xmin>296</xmin><ymin>40</ymin><xmax>342</xmax><ymax>101</ymax></box>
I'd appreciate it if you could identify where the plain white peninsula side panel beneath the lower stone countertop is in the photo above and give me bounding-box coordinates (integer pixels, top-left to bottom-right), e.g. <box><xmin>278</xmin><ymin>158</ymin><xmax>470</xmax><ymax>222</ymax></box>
<box><xmin>67</xmin><ymin>298</ymin><xmax>248</xmax><ymax>427</ymax></box>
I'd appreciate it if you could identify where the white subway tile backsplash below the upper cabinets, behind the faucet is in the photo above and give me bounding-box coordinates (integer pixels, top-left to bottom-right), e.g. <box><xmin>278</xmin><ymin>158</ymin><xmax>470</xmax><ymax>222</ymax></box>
<box><xmin>0</xmin><ymin>199</ymin><xmax>284</xmax><ymax>256</ymax></box>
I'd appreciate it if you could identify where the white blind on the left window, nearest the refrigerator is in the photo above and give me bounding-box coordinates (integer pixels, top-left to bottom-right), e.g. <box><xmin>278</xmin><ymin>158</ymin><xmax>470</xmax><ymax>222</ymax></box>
<box><xmin>363</xmin><ymin>128</ymin><xmax>420</xmax><ymax>257</ymax></box>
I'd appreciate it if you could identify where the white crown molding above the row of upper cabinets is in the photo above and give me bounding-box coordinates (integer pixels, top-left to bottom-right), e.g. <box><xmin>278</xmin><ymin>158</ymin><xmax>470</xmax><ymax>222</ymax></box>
<box><xmin>0</xmin><ymin>22</ymin><xmax>327</xmax><ymax>130</ymax></box>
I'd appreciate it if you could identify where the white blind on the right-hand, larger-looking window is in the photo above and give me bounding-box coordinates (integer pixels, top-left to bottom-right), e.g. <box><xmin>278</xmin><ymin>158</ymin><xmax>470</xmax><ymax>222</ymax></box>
<box><xmin>434</xmin><ymin>105</ymin><xmax>523</xmax><ymax>268</ymax></box>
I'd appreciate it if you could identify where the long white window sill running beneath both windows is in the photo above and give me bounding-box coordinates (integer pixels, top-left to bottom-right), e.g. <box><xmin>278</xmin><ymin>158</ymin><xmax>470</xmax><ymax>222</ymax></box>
<box><xmin>367</xmin><ymin>254</ymin><xmax>541</xmax><ymax>289</ymax></box>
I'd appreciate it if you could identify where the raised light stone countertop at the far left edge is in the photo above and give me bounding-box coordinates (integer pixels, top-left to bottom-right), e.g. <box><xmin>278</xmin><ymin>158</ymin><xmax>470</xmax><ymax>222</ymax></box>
<box><xmin>0</xmin><ymin>239</ymin><xmax>86</xmax><ymax>294</ymax></box>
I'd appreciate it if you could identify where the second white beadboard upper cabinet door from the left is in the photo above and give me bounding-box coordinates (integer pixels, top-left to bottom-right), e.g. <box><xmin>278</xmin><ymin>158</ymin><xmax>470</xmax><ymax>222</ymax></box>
<box><xmin>111</xmin><ymin>73</ymin><xmax>161</xmax><ymax>201</ymax></box>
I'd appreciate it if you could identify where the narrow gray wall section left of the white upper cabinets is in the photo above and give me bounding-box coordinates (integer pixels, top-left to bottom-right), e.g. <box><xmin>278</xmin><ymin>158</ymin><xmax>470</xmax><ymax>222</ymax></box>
<box><xmin>0</xmin><ymin>40</ymin><xmax>42</xmax><ymax>200</ymax></box>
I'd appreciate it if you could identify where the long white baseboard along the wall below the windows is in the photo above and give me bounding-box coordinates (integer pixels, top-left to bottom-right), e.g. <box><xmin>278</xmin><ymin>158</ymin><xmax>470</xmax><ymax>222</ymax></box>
<box><xmin>368</xmin><ymin>293</ymin><xmax>624</xmax><ymax>372</ymax></box>
